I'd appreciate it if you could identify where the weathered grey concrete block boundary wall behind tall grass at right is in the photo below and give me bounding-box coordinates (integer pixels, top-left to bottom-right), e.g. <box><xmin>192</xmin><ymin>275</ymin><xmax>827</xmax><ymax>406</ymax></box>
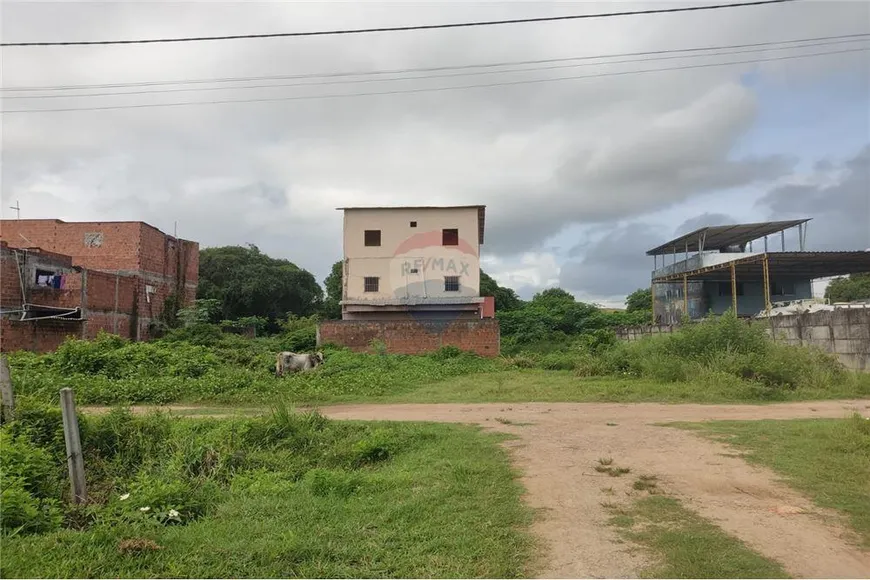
<box><xmin>616</xmin><ymin>308</ymin><xmax>870</xmax><ymax>372</ymax></box>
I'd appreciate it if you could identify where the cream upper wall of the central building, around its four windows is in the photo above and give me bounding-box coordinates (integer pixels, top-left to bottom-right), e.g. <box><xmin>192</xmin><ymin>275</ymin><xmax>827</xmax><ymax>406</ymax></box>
<box><xmin>342</xmin><ymin>208</ymin><xmax>480</xmax><ymax>301</ymax></box>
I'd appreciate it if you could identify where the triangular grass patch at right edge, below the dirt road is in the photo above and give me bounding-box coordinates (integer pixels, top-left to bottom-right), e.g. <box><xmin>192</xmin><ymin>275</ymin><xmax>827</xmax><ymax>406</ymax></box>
<box><xmin>673</xmin><ymin>415</ymin><xmax>870</xmax><ymax>548</ymax></box>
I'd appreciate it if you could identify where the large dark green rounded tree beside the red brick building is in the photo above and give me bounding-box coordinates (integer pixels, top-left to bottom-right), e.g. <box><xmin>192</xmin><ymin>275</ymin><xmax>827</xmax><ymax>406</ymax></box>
<box><xmin>197</xmin><ymin>245</ymin><xmax>323</xmax><ymax>323</ymax></box>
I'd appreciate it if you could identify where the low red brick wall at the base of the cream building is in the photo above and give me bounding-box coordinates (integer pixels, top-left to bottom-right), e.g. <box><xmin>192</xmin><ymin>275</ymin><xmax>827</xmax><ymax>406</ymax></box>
<box><xmin>317</xmin><ymin>318</ymin><xmax>501</xmax><ymax>357</ymax></box>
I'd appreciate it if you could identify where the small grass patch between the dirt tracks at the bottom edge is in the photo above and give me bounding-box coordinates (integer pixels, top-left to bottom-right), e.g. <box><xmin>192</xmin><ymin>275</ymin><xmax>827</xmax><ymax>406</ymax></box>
<box><xmin>610</xmin><ymin>494</ymin><xmax>788</xmax><ymax>578</ymax></box>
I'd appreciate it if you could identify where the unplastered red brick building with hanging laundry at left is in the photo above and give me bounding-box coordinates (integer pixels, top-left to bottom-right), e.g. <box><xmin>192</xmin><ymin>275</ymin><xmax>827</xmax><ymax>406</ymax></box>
<box><xmin>0</xmin><ymin>220</ymin><xmax>199</xmax><ymax>352</ymax></box>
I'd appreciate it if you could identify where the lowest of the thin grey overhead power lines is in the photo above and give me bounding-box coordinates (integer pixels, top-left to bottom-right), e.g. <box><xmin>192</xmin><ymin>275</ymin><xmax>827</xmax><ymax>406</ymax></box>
<box><xmin>0</xmin><ymin>47</ymin><xmax>868</xmax><ymax>115</ymax></box>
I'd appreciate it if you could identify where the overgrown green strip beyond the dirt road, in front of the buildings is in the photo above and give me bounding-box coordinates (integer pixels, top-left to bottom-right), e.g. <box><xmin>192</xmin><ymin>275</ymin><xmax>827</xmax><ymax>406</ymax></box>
<box><xmin>9</xmin><ymin>318</ymin><xmax>870</xmax><ymax>406</ymax></box>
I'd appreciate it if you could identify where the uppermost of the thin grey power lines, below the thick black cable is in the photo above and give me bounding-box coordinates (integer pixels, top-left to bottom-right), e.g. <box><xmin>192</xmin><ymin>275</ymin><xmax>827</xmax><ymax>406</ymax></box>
<box><xmin>0</xmin><ymin>32</ymin><xmax>870</xmax><ymax>93</ymax></box>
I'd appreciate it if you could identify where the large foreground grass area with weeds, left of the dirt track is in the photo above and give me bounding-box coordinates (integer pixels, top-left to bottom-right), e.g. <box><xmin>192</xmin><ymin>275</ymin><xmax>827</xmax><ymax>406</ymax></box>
<box><xmin>0</xmin><ymin>406</ymin><xmax>534</xmax><ymax>578</ymax></box>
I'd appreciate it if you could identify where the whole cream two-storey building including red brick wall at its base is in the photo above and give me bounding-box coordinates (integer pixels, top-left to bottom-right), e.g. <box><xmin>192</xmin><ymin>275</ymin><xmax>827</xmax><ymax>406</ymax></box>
<box><xmin>317</xmin><ymin>205</ymin><xmax>500</xmax><ymax>356</ymax></box>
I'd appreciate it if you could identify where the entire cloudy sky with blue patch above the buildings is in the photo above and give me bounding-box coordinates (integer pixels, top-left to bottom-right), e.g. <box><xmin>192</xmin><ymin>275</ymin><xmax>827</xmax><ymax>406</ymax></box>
<box><xmin>0</xmin><ymin>0</ymin><xmax>870</xmax><ymax>304</ymax></box>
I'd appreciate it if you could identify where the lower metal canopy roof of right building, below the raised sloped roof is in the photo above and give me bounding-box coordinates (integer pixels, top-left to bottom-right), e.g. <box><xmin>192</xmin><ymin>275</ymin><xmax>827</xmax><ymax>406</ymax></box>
<box><xmin>653</xmin><ymin>251</ymin><xmax>870</xmax><ymax>282</ymax></box>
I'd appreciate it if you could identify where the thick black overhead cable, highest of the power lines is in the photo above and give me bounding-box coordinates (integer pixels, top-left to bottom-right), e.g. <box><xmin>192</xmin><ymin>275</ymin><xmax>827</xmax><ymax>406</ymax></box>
<box><xmin>0</xmin><ymin>0</ymin><xmax>796</xmax><ymax>46</ymax></box>
